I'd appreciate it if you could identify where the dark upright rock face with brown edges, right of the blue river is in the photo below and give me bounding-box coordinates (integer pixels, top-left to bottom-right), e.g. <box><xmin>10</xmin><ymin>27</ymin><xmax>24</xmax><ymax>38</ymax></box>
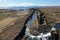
<box><xmin>37</xmin><ymin>11</ymin><xmax>46</xmax><ymax>26</ymax></box>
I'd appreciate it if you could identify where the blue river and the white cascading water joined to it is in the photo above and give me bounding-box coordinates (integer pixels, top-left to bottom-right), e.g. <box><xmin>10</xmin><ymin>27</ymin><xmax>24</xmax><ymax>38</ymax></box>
<box><xmin>25</xmin><ymin>12</ymin><xmax>55</xmax><ymax>40</ymax></box>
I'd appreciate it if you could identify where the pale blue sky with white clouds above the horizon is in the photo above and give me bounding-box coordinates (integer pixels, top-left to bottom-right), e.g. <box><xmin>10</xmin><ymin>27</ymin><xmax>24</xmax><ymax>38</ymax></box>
<box><xmin>0</xmin><ymin>0</ymin><xmax>60</xmax><ymax>7</ymax></box>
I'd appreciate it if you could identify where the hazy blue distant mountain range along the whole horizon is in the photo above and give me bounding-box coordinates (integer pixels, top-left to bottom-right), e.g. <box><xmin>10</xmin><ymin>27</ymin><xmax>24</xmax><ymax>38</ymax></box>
<box><xmin>0</xmin><ymin>6</ymin><xmax>60</xmax><ymax>10</ymax></box>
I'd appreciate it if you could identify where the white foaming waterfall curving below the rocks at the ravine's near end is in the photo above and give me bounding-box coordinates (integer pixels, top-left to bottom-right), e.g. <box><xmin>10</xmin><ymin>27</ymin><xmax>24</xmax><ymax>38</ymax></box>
<box><xmin>25</xmin><ymin>28</ymin><xmax>51</xmax><ymax>40</ymax></box>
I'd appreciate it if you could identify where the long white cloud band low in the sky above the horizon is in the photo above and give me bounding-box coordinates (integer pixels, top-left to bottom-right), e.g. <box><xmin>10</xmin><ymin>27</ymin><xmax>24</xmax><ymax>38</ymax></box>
<box><xmin>0</xmin><ymin>0</ymin><xmax>58</xmax><ymax>7</ymax></box>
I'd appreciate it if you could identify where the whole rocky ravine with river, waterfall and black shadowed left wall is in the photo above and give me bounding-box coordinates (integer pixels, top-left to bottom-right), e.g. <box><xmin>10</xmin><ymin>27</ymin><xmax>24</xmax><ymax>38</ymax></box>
<box><xmin>14</xmin><ymin>10</ymin><xmax>58</xmax><ymax>40</ymax></box>
